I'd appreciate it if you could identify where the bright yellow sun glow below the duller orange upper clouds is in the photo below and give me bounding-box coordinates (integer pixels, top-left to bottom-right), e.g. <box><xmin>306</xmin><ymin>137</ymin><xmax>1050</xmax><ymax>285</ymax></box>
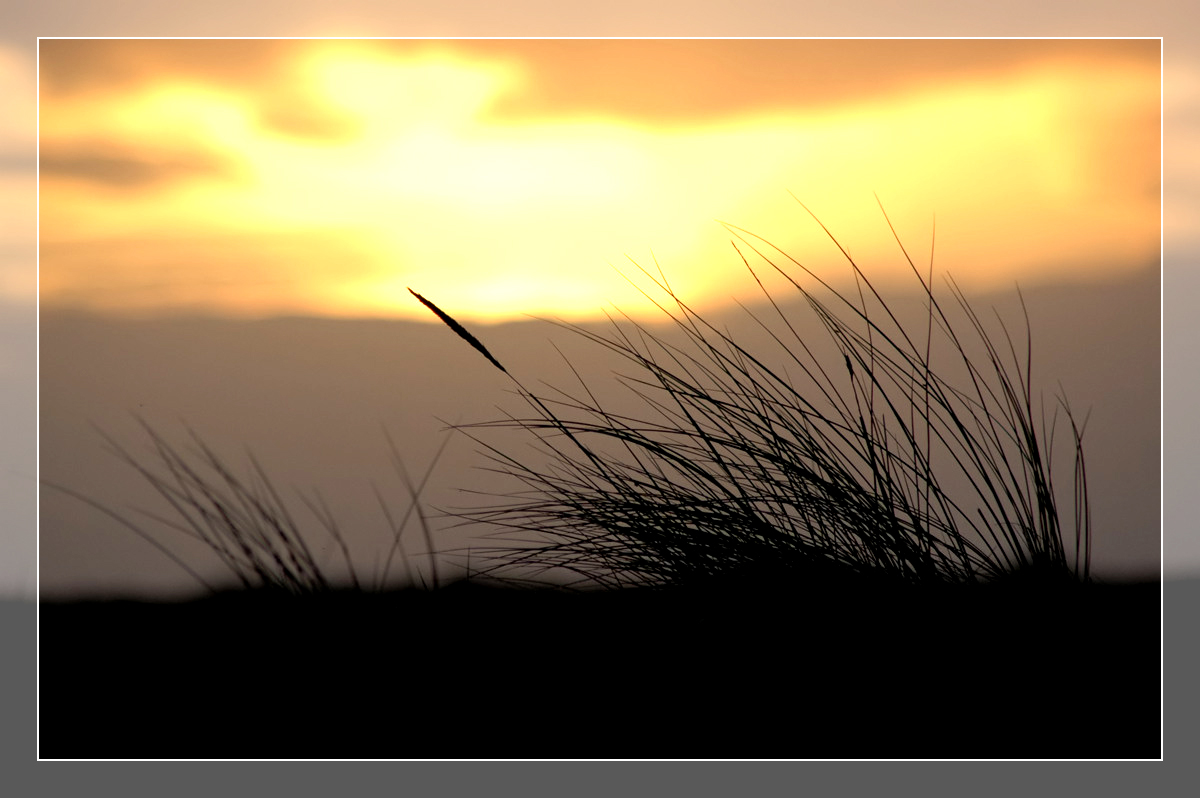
<box><xmin>41</xmin><ymin>43</ymin><xmax>1159</xmax><ymax>319</ymax></box>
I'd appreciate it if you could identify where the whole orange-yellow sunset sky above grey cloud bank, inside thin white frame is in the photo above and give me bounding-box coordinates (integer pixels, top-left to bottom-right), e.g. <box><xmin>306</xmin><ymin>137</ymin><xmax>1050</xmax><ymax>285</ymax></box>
<box><xmin>38</xmin><ymin>40</ymin><xmax>1160</xmax><ymax>320</ymax></box>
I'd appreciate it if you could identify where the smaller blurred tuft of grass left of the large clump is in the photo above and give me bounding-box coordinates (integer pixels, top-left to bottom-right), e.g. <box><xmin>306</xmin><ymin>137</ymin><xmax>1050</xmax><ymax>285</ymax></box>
<box><xmin>53</xmin><ymin>418</ymin><xmax>445</xmax><ymax>595</ymax></box>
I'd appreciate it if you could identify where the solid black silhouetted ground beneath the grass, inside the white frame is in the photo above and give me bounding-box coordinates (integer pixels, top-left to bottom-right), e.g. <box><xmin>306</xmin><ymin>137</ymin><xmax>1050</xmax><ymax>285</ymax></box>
<box><xmin>40</xmin><ymin>573</ymin><xmax>1162</xmax><ymax>760</ymax></box>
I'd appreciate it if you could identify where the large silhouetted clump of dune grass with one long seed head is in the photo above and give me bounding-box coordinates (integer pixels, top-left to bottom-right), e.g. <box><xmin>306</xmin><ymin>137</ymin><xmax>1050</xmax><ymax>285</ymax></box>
<box><xmin>414</xmin><ymin>204</ymin><xmax>1091</xmax><ymax>587</ymax></box>
